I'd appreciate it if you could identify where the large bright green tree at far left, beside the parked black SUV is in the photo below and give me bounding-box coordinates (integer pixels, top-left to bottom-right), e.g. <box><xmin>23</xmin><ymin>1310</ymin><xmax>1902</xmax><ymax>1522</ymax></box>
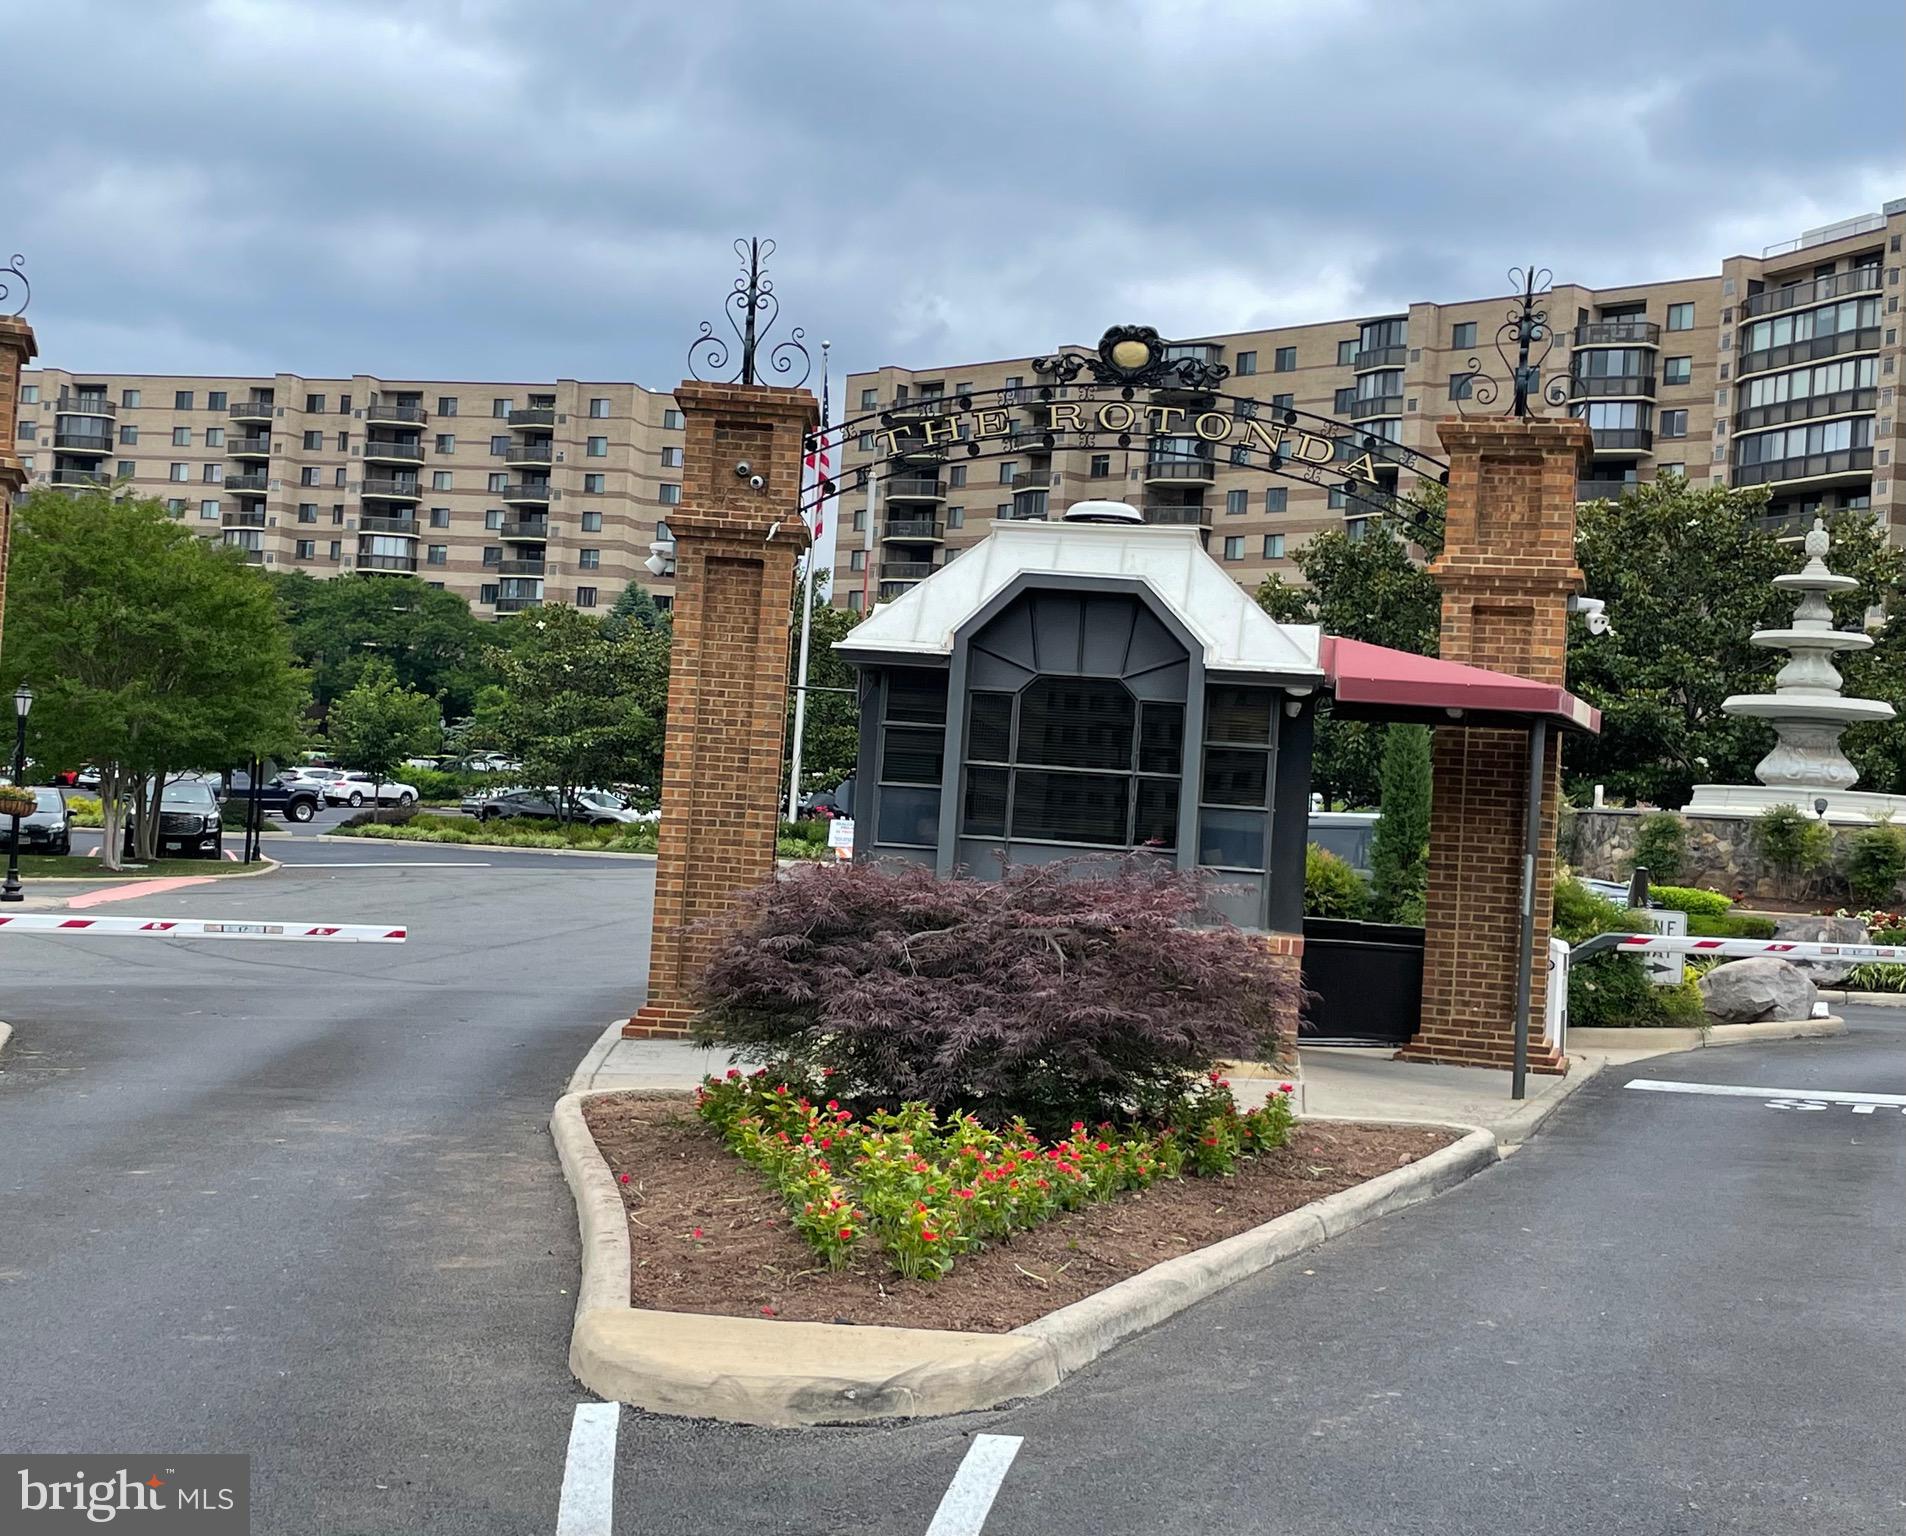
<box><xmin>0</xmin><ymin>490</ymin><xmax>307</xmax><ymax>869</ymax></box>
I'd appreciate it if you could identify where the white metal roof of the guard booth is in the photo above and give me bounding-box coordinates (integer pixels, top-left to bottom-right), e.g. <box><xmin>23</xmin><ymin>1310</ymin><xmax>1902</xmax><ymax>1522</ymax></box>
<box><xmin>835</xmin><ymin>520</ymin><xmax>1323</xmax><ymax>680</ymax></box>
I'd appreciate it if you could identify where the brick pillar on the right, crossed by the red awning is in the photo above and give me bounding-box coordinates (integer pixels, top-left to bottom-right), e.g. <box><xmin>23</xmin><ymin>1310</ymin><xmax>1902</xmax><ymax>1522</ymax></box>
<box><xmin>1401</xmin><ymin>419</ymin><xmax>1592</xmax><ymax>1071</ymax></box>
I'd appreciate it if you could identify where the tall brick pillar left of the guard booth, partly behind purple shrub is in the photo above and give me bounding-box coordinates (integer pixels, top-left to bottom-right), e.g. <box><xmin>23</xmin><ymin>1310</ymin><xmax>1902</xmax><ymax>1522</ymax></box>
<box><xmin>621</xmin><ymin>383</ymin><xmax>820</xmax><ymax>1039</ymax></box>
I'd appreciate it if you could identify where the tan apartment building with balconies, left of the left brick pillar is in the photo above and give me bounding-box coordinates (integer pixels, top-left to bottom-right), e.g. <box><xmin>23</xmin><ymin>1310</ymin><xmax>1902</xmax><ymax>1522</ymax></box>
<box><xmin>15</xmin><ymin>368</ymin><xmax>682</xmax><ymax>616</ymax></box>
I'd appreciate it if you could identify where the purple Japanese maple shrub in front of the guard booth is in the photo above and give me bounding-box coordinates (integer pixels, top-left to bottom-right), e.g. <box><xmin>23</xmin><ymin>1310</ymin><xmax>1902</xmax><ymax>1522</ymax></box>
<box><xmin>698</xmin><ymin>861</ymin><xmax>1302</xmax><ymax>1126</ymax></box>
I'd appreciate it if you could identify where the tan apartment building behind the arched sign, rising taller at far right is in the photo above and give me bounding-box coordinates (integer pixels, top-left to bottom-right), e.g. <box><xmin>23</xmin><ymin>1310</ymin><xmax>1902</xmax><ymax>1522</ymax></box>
<box><xmin>833</xmin><ymin>198</ymin><xmax>1906</xmax><ymax>608</ymax></box>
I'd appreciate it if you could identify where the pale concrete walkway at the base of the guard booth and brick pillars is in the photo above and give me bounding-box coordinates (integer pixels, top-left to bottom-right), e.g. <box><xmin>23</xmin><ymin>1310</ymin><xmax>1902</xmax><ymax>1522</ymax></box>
<box><xmin>568</xmin><ymin>1020</ymin><xmax>1611</xmax><ymax>1147</ymax></box>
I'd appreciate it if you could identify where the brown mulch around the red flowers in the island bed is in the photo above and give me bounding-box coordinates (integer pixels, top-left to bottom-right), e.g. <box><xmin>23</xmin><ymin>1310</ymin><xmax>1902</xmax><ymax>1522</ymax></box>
<box><xmin>583</xmin><ymin>1094</ymin><xmax>1456</xmax><ymax>1332</ymax></box>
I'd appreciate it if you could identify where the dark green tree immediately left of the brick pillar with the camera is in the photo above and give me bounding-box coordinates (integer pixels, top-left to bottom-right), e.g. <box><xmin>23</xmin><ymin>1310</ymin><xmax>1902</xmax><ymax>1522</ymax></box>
<box><xmin>492</xmin><ymin>604</ymin><xmax>669</xmax><ymax>819</ymax></box>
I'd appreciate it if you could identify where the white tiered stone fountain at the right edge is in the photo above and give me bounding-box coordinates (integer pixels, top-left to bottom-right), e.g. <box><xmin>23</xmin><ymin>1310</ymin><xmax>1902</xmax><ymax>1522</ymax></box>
<box><xmin>1687</xmin><ymin>518</ymin><xmax>1906</xmax><ymax>821</ymax></box>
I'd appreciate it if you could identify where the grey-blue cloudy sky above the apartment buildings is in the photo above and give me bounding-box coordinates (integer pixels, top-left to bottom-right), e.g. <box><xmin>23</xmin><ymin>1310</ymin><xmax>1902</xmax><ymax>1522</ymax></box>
<box><xmin>0</xmin><ymin>0</ymin><xmax>1906</xmax><ymax>387</ymax></box>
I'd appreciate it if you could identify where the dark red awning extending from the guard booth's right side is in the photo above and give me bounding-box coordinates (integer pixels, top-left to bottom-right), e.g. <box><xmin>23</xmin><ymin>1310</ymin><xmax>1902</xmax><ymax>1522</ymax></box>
<box><xmin>1321</xmin><ymin>635</ymin><xmax>1601</xmax><ymax>732</ymax></box>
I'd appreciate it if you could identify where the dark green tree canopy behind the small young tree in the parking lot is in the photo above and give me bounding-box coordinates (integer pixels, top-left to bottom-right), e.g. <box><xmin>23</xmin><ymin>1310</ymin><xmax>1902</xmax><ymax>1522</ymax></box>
<box><xmin>273</xmin><ymin>572</ymin><xmax>497</xmax><ymax>717</ymax></box>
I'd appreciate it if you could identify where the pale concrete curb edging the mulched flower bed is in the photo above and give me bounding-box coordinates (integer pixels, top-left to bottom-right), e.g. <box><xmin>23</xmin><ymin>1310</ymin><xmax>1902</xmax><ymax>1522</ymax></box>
<box><xmin>549</xmin><ymin>1094</ymin><xmax>1500</xmax><ymax>1429</ymax></box>
